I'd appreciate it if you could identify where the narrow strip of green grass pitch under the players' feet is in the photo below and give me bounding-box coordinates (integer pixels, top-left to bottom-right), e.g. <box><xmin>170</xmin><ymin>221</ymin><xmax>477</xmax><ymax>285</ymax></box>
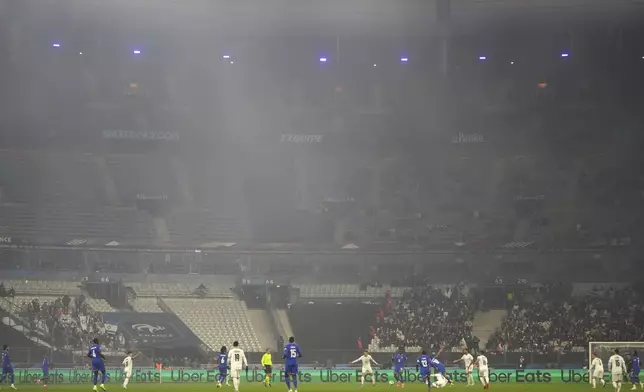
<box><xmin>2</xmin><ymin>383</ymin><xmax>604</xmax><ymax>392</ymax></box>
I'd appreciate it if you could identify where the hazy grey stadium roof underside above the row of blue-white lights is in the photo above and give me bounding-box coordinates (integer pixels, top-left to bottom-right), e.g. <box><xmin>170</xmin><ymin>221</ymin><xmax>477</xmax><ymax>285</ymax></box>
<box><xmin>16</xmin><ymin>0</ymin><xmax>644</xmax><ymax>38</ymax></box>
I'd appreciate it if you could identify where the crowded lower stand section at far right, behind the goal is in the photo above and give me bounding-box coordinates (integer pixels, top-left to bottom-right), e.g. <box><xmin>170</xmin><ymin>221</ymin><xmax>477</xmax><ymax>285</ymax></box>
<box><xmin>488</xmin><ymin>287</ymin><xmax>644</xmax><ymax>353</ymax></box>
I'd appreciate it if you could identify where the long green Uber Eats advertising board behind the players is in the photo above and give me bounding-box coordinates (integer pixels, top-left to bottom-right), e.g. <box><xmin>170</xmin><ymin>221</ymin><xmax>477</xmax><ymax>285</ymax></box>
<box><xmin>10</xmin><ymin>368</ymin><xmax>596</xmax><ymax>384</ymax></box>
